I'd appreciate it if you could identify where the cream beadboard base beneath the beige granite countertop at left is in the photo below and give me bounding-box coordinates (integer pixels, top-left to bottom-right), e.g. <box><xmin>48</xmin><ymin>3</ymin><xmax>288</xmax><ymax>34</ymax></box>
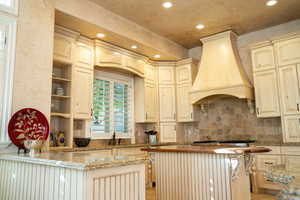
<box><xmin>0</xmin><ymin>160</ymin><xmax>145</xmax><ymax>200</ymax></box>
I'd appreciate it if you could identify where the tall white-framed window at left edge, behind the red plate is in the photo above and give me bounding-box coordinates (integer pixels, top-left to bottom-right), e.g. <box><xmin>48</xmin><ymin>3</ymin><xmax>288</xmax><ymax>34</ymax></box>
<box><xmin>0</xmin><ymin>14</ymin><xmax>16</xmax><ymax>146</ymax></box>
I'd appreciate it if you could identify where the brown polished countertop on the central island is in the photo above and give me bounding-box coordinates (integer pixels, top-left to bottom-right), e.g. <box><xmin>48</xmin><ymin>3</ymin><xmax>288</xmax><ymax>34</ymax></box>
<box><xmin>142</xmin><ymin>145</ymin><xmax>271</xmax><ymax>154</ymax></box>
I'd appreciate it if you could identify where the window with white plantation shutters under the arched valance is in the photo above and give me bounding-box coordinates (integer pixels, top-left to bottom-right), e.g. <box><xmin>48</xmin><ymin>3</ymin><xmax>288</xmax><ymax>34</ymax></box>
<box><xmin>91</xmin><ymin>71</ymin><xmax>133</xmax><ymax>139</ymax></box>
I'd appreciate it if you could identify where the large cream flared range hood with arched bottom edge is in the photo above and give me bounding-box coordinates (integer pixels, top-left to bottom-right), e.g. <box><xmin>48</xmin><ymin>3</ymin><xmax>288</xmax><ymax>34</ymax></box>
<box><xmin>190</xmin><ymin>31</ymin><xmax>253</xmax><ymax>104</ymax></box>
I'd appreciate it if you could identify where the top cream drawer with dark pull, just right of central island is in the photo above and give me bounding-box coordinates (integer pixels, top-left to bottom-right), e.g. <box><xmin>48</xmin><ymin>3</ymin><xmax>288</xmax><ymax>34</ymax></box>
<box><xmin>256</xmin><ymin>155</ymin><xmax>282</xmax><ymax>171</ymax></box>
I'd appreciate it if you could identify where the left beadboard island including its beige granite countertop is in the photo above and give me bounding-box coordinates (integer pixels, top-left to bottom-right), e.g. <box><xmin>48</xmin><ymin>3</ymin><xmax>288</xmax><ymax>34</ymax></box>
<box><xmin>0</xmin><ymin>151</ymin><xmax>147</xmax><ymax>200</ymax></box>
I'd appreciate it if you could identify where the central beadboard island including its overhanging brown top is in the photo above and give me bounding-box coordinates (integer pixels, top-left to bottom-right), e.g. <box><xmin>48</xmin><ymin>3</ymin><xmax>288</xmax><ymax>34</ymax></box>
<box><xmin>142</xmin><ymin>145</ymin><xmax>270</xmax><ymax>200</ymax></box>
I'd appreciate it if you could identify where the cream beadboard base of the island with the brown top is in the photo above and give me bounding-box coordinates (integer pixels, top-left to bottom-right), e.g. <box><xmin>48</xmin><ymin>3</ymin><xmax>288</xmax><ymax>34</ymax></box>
<box><xmin>155</xmin><ymin>153</ymin><xmax>250</xmax><ymax>200</ymax></box>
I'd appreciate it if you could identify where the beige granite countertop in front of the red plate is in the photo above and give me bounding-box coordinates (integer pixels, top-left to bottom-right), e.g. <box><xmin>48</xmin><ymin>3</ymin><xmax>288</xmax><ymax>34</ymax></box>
<box><xmin>0</xmin><ymin>150</ymin><xmax>147</xmax><ymax>170</ymax></box>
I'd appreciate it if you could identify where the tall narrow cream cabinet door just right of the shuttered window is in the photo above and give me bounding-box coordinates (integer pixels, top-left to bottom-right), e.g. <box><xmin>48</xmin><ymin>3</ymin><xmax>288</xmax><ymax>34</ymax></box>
<box><xmin>145</xmin><ymin>84</ymin><xmax>158</xmax><ymax>122</ymax></box>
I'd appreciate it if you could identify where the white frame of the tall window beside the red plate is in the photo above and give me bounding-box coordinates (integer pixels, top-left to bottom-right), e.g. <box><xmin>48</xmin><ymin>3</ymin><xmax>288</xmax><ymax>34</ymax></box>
<box><xmin>0</xmin><ymin>12</ymin><xmax>17</xmax><ymax>147</ymax></box>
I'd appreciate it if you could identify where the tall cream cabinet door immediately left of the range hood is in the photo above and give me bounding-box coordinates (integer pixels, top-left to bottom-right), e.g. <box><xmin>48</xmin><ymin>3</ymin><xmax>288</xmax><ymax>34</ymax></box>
<box><xmin>177</xmin><ymin>83</ymin><xmax>193</xmax><ymax>122</ymax></box>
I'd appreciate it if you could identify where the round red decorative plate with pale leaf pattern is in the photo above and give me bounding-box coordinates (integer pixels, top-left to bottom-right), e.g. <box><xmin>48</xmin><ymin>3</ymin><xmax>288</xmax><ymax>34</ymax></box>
<box><xmin>8</xmin><ymin>108</ymin><xmax>49</xmax><ymax>149</ymax></box>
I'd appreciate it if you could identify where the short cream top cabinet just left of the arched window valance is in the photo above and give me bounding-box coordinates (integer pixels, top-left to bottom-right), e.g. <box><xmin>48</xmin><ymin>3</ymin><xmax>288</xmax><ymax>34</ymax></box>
<box><xmin>75</xmin><ymin>37</ymin><xmax>94</xmax><ymax>70</ymax></box>
